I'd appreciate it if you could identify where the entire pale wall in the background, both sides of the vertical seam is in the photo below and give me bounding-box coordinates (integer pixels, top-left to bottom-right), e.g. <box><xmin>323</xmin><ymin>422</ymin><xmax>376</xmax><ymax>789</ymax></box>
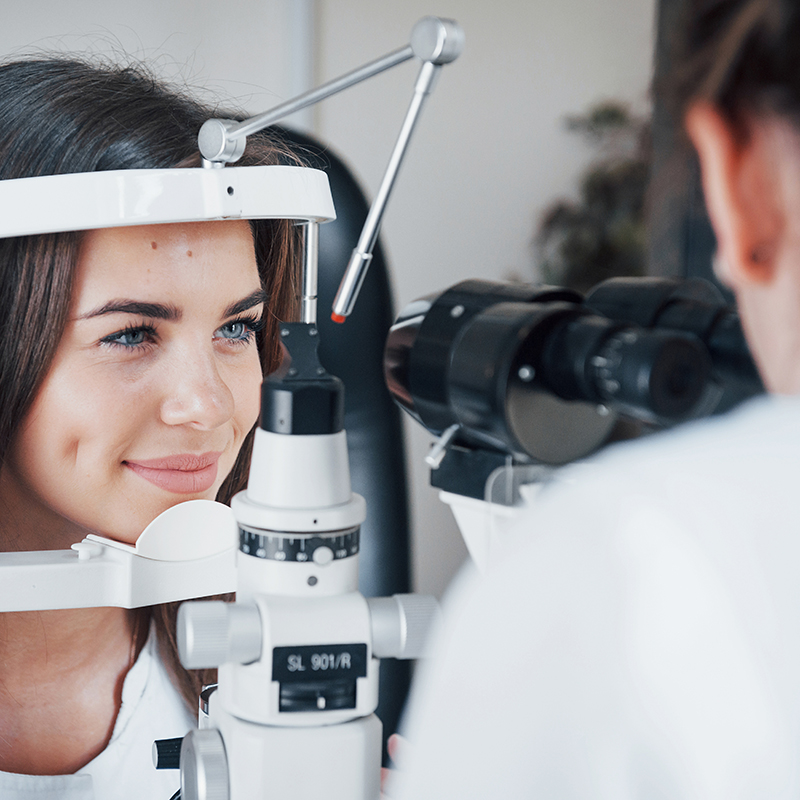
<box><xmin>0</xmin><ymin>0</ymin><xmax>655</xmax><ymax>594</ymax></box>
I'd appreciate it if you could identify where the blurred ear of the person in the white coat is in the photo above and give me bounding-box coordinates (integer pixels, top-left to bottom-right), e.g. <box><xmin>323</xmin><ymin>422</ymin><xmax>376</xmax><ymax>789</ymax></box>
<box><xmin>685</xmin><ymin>101</ymin><xmax>789</xmax><ymax>289</ymax></box>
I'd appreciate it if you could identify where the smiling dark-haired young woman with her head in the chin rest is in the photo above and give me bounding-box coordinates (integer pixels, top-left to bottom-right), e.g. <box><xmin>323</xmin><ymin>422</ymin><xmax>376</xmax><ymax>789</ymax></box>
<box><xmin>0</xmin><ymin>59</ymin><xmax>294</xmax><ymax>800</ymax></box>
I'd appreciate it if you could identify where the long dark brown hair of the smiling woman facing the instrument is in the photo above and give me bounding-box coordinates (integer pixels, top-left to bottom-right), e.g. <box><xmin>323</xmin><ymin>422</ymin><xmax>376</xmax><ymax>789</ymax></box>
<box><xmin>0</xmin><ymin>57</ymin><xmax>298</xmax><ymax>709</ymax></box>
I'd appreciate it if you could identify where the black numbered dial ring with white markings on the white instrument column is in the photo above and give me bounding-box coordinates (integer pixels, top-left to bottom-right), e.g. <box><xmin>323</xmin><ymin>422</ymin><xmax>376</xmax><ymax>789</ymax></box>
<box><xmin>239</xmin><ymin>527</ymin><xmax>360</xmax><ymax>565</ymax></box>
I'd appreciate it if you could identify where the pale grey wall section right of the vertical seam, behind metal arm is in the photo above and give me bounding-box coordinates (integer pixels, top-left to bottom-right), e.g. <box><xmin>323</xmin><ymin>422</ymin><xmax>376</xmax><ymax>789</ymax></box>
<box><xmin>316</xmin><ymin>0</ymin><xmax>655</xmax><ymax>594</ymax></box>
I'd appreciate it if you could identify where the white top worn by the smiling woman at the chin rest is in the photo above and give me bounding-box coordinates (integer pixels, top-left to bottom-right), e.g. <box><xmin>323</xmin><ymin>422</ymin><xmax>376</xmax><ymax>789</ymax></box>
<box><xmin>0</xmin><ymin>629</ymin><xmax>196</xmax><ymax>800</ymax></box>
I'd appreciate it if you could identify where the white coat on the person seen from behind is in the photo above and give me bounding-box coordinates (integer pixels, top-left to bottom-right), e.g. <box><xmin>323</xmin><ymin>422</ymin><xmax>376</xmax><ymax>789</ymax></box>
<box><xmin>389</xmin><ymin>397</ymin><xmax>800</xmax><ymax>800</ymax></box>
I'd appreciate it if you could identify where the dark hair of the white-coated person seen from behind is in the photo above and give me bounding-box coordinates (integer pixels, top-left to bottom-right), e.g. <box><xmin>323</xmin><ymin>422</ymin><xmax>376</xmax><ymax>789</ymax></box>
<box><xmin>656</xmin><ymin>0</ymin><xmax>800</xmax><ymax>132</ymax></box>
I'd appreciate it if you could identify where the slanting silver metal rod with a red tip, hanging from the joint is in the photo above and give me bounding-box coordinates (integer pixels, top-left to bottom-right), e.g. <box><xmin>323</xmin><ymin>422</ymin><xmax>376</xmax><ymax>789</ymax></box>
<box><xmin>332</xmin><ymin>61</ymin><xmax>441</xmax><ymax>322</ymax></box>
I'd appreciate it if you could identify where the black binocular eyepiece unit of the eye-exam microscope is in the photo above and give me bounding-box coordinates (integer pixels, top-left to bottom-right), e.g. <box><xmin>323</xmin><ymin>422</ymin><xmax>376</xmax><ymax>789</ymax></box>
<box><xmin>384</xmin><ymin>279</ymin><xmax>761</xmax><ymax>464</ymax></box>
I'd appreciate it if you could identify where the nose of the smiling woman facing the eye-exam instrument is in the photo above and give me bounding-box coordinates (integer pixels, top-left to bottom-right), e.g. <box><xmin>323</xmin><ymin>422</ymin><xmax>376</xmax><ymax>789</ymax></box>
<box><xmin>161</xmin><ymin>352</ymin><xmax>234</xmax><ymax>430</ymax></box>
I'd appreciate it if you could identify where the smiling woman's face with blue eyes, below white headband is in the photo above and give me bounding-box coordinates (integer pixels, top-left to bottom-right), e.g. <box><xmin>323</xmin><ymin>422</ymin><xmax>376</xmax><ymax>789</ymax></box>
<box><xmin>0</xmin><ymin>221</ymin><xmax>265</xmax><ymax>547</ymax></box>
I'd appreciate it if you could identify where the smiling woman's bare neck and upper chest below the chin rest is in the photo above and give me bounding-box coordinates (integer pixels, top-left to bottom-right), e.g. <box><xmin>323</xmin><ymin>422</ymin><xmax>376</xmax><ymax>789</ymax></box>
<box><xmin>0</xmin><ymin>608</ymin><xmax>146</xmax><ymax>775</ymax></box>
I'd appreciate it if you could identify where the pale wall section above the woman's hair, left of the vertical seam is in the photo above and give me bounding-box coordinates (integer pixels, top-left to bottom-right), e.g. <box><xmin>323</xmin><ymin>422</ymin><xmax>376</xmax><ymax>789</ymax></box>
<box><xmin>0</xmin><ymin>0</ymin><xmax>308</xmax><ymax>112</ymax></box>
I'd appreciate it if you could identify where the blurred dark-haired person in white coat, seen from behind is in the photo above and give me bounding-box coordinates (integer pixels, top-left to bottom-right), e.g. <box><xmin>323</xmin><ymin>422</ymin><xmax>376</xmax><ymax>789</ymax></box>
<box><xmin>389</xmin><ymin>0</ymin><xmax>800</xmax><ymax>800</ymax></box>
